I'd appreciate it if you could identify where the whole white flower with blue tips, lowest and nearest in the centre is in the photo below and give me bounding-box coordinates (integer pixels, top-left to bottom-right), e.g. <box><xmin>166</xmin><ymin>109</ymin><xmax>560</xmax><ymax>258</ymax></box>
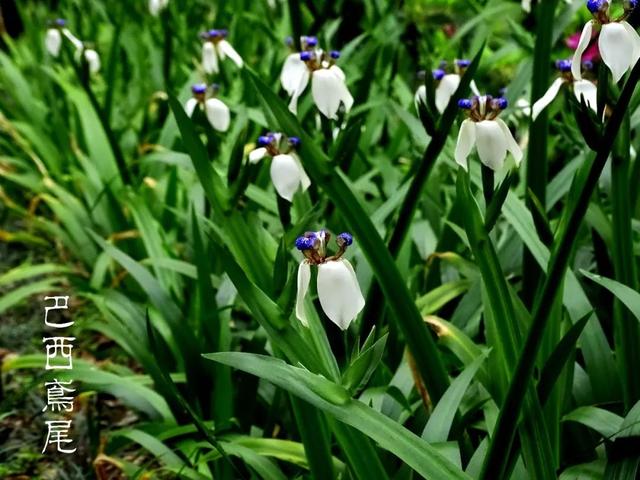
<box><xmin>296</xmin><ymin>230</ymin><xmax>364</xmax><ymax>330</ymax></box>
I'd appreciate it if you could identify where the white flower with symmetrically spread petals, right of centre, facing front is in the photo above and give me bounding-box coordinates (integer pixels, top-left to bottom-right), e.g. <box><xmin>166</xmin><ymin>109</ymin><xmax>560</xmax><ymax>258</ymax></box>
<box><xmin>455</xmin><ymin>96</ymin><xmax>522</xmax><ymax>171</ymax></box>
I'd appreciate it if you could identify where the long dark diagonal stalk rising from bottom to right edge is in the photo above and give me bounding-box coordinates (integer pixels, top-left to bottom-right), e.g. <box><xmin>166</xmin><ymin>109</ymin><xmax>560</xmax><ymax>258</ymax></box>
<box><xmin>480</xmin><ymin>62</ymin><xmax>640</xmax><ymax>480</ymax></box>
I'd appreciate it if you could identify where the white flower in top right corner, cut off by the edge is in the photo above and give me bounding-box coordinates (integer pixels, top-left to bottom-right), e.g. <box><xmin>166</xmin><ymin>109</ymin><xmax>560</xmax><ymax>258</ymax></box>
<box><xmin>571</xmin><ymin>0</ymin><xmax>640</xmax><ymax>82</ymax></box>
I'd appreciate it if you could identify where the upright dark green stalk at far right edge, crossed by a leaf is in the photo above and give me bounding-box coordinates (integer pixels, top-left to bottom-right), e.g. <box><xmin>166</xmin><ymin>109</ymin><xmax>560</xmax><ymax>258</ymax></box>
<box><xmin>611</xmin><ymin>113</ymin><xmax>640</xmax><ymax>411</ymax></box>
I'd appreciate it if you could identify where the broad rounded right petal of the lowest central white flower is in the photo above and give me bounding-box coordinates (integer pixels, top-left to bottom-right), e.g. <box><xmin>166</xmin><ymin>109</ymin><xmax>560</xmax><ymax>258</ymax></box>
<box><xmin>318</xmin><ymin>259</ymin><xmax>364</xmax><ymax>330</ymax></box>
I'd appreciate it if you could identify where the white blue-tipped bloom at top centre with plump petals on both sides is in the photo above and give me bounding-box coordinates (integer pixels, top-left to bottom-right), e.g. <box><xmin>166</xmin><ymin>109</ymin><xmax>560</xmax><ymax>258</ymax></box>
<box><xmin>280</xmin><ymin>37</ymin><xmax>353</xmax><ymax>119</ymax></box>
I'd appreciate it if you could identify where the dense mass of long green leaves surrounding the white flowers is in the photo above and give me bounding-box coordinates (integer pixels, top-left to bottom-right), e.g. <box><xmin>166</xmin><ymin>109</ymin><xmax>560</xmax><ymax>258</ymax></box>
<box><xmin>0</xmin><ymin>0</ymin><xmax>640</xmax><ymax>479</ymax></box>
